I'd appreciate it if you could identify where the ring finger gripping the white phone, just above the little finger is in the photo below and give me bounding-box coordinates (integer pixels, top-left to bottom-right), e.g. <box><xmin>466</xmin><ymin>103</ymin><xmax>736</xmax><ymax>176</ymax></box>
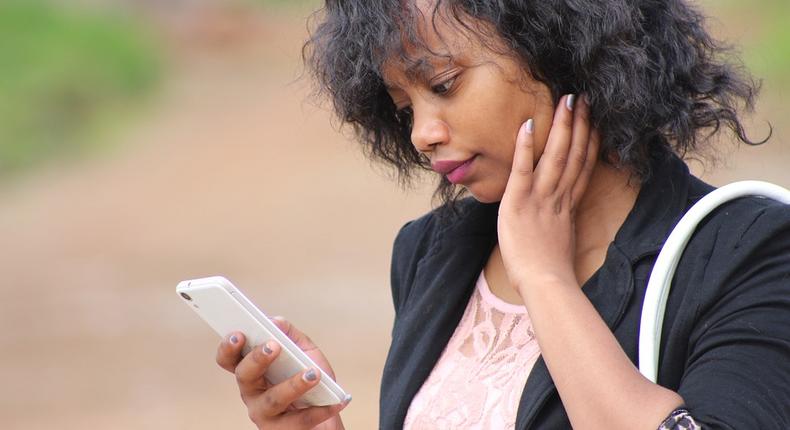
<box><xmin>247</xmin><ymin>368</ymin><xmax>321</xmax><ymax>420</ymax></box>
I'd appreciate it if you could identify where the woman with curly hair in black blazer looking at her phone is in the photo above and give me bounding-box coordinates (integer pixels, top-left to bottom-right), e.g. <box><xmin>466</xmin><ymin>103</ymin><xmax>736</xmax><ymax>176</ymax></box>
<box><xmin>217</xmin><ymin>0</ymin><xmax>790</xmax><ymax>429</ymax></box>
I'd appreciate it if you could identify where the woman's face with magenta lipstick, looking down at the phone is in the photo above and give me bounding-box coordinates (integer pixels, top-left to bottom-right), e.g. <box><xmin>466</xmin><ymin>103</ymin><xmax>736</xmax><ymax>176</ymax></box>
<box><xmin>382</xmin><ymin>13</ymin><xmax>554</xmax><ymax>203</ymax></box>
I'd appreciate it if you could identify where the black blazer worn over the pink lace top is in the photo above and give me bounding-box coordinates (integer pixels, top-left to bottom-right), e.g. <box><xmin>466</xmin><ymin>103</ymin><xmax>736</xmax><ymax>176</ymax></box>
<box><xmin>380</xmin><ymin>157</ymin><xmax>790</xmax><ymax>430</ymax></box>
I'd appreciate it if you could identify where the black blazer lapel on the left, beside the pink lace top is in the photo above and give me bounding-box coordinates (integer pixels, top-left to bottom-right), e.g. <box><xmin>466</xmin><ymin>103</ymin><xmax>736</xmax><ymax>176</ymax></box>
<box><xmin>381</xmin><ymin>203</ymin><xmax>497</xmax><ymax>429</ymax></box>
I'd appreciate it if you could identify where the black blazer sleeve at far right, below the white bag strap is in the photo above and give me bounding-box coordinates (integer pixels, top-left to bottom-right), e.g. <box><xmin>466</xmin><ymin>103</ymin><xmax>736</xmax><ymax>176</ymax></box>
<box><xmin>678</xmin><ymin>205</ymin><xmax>790</xmax><ymax>430</ymax></box>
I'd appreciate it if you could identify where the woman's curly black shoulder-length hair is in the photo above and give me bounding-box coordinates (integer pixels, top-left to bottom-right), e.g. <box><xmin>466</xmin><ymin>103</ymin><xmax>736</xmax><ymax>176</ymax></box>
<box><xmin>303</xmin><ymin>0</ymin><xmax>770</xmax><ymax>202</ymax></box>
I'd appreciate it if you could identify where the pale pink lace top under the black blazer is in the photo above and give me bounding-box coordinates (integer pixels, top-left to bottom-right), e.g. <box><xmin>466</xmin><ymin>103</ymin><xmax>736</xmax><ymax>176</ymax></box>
<box><xmin>403</xmin><ymin>272</ymin><xmax>540</xmax><ymax>430</ymax></box>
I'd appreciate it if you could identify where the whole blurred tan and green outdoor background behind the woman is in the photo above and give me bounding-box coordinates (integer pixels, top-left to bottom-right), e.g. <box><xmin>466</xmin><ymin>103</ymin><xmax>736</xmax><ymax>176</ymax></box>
<box><xmin>0</xmin><ymin>0</ymin><xmax>790</xmax><ymax>430</ymax></box>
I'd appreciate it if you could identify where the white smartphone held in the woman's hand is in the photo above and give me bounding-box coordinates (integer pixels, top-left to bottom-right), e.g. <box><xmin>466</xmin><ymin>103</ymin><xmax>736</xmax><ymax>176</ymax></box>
<box><xmin>176</xmin><ymin>276</ymin><xmax>351</xmax><ymax>407</ymax></box>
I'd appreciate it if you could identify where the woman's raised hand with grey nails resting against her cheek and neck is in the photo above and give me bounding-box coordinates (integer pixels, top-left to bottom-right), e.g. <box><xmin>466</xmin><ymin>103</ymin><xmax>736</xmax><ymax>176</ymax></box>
<box><xmin>498</xmin><ymin>95</ymin><xmax>599</xmax><ymax>295</ymax></box>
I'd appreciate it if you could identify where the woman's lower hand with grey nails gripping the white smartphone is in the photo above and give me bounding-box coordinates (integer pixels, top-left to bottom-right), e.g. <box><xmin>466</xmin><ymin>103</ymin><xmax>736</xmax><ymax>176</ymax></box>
<box><xmin>217</xmin><ymin>317</ymin><xmax>347</xmax><ymax>430</ymax></box>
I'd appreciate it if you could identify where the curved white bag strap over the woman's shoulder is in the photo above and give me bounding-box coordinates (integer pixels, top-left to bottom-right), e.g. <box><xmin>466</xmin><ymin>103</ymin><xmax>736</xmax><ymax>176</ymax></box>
<box><xmin>639</xmin><ymin>181</ymin><xmax>790</xmax><ymax>382</ymax></box>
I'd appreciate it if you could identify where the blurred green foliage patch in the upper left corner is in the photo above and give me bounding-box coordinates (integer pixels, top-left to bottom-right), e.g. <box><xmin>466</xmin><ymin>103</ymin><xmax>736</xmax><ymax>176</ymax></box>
<box><xmin>0</xmin><ymin>0</ymin><xmax>159</xmax><ymax>175</ymax></box>
